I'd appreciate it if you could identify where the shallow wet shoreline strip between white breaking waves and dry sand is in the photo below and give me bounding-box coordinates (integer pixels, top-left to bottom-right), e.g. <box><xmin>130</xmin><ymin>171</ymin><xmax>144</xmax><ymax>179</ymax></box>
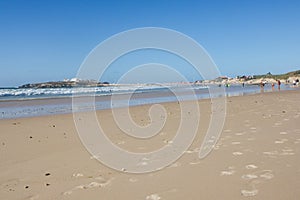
<box><xmin>0</xmin><ymin>86</ymin><xmax>300</xmax><ymax>120</ymax></box>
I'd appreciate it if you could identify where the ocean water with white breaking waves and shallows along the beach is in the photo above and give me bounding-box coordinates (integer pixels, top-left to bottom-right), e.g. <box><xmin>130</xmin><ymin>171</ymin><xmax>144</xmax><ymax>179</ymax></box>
<box><xmin>0</xmin><ymin>84</ymin><xmax>295</xmax><ymax>119</ymax></box>
